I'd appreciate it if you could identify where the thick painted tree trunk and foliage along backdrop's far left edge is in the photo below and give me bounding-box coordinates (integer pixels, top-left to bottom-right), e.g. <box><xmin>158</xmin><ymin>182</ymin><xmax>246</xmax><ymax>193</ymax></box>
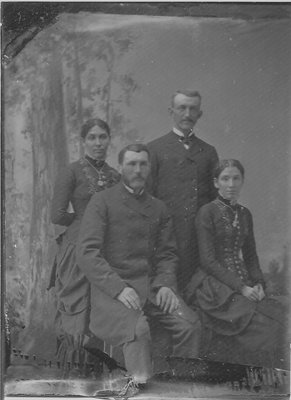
<box><xmin>5</xmin><ymin>32</ymin><xmax>67</xmax><ymax>352</ymax></box>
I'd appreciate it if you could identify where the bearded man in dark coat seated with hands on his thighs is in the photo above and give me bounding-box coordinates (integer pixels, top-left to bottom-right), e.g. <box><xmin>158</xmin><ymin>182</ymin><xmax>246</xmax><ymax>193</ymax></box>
<box><xmin>77</xmin><ymin>144</ymin><xmax>201</xmax><ymax>396</ymax></box>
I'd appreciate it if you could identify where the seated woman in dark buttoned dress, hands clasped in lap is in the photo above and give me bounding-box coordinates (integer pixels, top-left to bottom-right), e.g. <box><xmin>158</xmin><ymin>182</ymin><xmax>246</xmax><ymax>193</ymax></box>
<box><xmin>188</xmin><ymin>159</ymin><xmax>288</xmax><ymax>368</ymax></box>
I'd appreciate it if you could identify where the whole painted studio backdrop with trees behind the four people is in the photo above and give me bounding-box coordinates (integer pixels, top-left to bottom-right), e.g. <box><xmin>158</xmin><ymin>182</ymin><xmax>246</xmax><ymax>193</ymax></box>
<box><xmin>4</xmin><ymin>13</ymin><xmax>291</xmax><ymax>358</ymax></box>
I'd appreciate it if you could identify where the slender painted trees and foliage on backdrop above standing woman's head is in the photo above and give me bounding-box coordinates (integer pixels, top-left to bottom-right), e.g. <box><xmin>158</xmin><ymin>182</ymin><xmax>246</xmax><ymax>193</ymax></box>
<box><xmin>75</xmin><ymin>29</ymin><xmax>139</xmax><ymax>156</ymax></box>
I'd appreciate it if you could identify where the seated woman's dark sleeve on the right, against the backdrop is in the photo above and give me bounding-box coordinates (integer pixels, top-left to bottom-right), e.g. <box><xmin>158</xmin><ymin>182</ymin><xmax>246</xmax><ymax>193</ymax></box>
<box><xmin>242</xmin><ymin>210</ymin><xmax>265</xmax><ymax>286</ymax></box>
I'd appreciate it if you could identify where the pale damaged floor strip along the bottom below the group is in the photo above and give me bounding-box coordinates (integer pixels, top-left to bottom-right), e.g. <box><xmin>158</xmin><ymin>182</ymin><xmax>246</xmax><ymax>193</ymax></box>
<box><xmin>4</xmin><ymin>357</ymin><xmax>290</xmax><ymax>400</ymax></box>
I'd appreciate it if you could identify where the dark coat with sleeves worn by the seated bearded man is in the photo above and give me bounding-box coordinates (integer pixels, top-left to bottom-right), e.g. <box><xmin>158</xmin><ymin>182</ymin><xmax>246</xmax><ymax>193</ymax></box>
<box><xmin>77</xmin><ymin>183</ymin><xmax>178</xmax><ymax>345</ymax></box>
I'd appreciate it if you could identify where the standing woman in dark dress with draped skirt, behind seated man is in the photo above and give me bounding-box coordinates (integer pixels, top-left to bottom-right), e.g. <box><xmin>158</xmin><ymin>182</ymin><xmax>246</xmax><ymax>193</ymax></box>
<box><xmin>50</xmin><ymin>118</ymin><xmax>120</xmax><ymax>376</ymax></box>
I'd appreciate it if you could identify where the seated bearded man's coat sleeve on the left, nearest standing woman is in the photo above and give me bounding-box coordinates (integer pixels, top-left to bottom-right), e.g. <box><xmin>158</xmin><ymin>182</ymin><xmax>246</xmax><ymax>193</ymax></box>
<box><xmin>77</xmin><ymin>193</ymin><xmax>127</xmax><ymax>298</ymax></box>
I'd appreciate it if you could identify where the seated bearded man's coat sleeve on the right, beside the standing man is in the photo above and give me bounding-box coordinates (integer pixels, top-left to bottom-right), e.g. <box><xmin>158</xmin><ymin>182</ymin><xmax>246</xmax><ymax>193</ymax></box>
<box><xmin>152</xmin><ymin>206</ymin><xmax>178</xmax><ymax>291</ymax></box>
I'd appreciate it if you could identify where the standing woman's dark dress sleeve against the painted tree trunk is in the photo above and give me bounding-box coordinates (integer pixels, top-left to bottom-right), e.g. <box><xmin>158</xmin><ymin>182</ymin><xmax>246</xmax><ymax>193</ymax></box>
<box><xmin>51</xmin><ymin>167</ymin><xmax>75</xmax><ymax>226</ymax></box>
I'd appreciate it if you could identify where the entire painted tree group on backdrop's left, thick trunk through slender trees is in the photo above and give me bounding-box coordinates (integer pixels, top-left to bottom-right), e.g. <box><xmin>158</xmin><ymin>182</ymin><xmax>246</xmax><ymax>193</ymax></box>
<box><xmin>5</xmin><ymin>24</ymin><xmax>138</xmax><ymax>357</ymax></box>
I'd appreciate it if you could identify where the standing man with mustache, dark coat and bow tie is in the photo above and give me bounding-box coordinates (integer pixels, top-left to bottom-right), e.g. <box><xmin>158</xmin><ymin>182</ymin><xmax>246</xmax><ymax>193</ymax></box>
<box><xmin>148</xmin><ymin>90</ymin><xmax>218</xmax><ymax>294</ymax></box>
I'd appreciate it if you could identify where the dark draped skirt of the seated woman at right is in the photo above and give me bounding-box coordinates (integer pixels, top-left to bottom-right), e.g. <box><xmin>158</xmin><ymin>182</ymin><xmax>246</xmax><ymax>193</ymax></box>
<box><xmin>195</xmin><ymin>276</ymin><xmax>289</xmax><ymax>369</ymax></box>
